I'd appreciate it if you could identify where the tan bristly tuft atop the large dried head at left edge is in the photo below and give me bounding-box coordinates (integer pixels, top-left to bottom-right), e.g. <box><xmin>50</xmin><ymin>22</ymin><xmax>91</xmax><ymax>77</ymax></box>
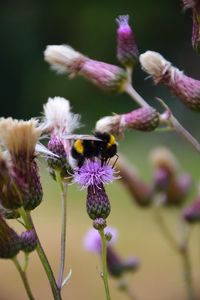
<box><xmin>0</xmin><ymin>118</ymin><xmax>42</xmax><ymax>159</ymax></box>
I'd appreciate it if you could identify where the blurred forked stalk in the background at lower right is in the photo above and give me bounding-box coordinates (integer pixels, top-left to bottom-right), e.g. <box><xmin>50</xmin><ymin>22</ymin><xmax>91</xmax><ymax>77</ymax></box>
<box><xmin>154</xmin><ymin>195</ymin><xmax>196</xmax><ymax>300</ymax></box>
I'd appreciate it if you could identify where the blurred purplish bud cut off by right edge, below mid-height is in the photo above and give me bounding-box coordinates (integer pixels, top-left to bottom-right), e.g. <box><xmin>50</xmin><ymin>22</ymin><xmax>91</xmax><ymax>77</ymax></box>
<box><xmin>183</xmin><ymin>197</ymin><xmax>200</xmax><ymax>224</ymax></box>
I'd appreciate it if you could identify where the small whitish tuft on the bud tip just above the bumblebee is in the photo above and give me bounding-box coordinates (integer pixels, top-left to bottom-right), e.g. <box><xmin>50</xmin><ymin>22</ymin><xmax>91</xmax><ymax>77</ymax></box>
<box><xmin>95</xmin><ymin>115</ymin><xmax>121</xmax><ymax>133</ymax></box>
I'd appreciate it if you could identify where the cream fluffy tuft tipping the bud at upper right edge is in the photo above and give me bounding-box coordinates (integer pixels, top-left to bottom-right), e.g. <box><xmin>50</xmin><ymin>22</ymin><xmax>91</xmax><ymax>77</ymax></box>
<box><xmin>139</xmin><ymin>51</ymin><xmax>171</xmax><ymax>79</ymax></box>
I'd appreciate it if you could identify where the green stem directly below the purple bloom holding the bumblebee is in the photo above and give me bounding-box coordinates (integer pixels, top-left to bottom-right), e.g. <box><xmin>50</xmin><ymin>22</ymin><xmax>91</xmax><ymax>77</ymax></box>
<box><xmin>99</xmin><ymin>229</ymin><xmax>111</xmax><ymax>300</ymax></box>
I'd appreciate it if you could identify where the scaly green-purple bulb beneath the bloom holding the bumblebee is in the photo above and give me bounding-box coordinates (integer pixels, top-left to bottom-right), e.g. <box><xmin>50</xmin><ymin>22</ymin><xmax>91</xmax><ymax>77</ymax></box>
<box><xmin>86</xmin><ymin>185</ymin><xmax>111</xmax><ymax>220</ymax></box>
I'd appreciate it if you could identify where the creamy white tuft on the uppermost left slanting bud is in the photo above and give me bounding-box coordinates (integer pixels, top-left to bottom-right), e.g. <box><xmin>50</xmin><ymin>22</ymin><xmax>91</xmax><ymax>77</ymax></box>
<box><xmin>44</xmin><ymin>45</ymin><xmax>84</xmax><ymax>74</ymax></box>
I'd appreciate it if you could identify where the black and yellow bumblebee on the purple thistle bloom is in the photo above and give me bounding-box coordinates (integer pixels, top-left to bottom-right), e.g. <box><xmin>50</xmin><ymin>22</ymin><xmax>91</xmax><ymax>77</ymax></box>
<box><xmin>71</xmin><ymin>131</ymin><xmax>118</xmax><ymax>167</ymax></box>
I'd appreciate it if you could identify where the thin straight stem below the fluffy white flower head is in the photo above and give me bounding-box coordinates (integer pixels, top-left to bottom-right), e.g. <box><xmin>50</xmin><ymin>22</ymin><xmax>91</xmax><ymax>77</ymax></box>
<box><xmin>56</xmin><ymin>172</ymin><xmax>67</xmax><ymax>290</ymax></box>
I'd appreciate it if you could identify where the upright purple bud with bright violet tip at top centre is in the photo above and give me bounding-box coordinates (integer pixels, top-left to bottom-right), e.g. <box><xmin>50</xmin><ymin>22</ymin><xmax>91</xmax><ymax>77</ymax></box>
<box><xmin>116</xmin><ymin>15</ymin><xmax>139</xmax><ymax>67</ymax></box>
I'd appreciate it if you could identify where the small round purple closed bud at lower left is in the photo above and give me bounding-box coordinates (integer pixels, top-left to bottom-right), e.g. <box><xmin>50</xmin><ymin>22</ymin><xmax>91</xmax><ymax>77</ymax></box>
<box><xmin>20</xmin><ymin>229</ymin><xmax>38</xmax><ymax>253</ymax></box>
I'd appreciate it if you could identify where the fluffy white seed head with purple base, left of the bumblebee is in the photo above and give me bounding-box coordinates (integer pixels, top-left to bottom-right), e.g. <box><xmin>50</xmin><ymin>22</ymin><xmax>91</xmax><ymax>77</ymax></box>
<box><xmin>44</xmin><ymin>97</ymin><xmax>80</xmax><ymax>177</ymax></box>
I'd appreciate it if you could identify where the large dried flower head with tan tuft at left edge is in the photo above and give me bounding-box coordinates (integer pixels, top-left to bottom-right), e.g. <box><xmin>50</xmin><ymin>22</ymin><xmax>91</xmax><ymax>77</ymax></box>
<box><xmin>0</xmin><ymin>118</ymin><xmax>43</xmax><ymax>210</ymax></box>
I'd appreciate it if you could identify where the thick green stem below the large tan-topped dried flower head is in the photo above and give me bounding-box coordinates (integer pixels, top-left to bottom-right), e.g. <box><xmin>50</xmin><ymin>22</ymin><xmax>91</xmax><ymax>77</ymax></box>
<box><xmin>19</xmin><ymin>207</ymin><xmax>62</xmax><ymax>300</ymax></box>
